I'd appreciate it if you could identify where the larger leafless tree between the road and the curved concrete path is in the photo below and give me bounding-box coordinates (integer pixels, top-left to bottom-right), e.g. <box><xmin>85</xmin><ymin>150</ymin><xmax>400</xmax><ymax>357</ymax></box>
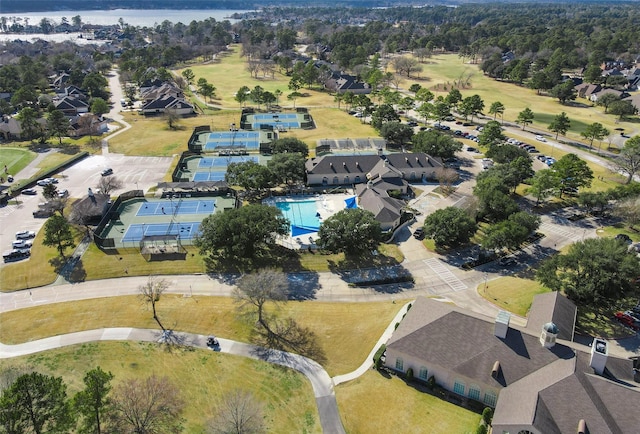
<box><xmin>233</xmin><ymin>270</ymin><xmax>289</xmax><ymax>329</ymax></box>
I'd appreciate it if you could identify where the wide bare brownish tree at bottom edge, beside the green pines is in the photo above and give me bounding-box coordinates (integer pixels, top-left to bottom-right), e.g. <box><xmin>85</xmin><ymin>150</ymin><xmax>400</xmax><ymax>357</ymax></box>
<box><xmin>111</xmin><ymin>375</ymin><xmax>185</xmax><ymax>434</ymax></box>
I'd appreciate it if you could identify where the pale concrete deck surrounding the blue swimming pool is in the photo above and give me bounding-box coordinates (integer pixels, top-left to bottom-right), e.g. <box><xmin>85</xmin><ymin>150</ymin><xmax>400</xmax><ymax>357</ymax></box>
<box><xmin>263</xmin><ymin>193</ymin><xmax>355</xmax><ymax>250</ymax></box>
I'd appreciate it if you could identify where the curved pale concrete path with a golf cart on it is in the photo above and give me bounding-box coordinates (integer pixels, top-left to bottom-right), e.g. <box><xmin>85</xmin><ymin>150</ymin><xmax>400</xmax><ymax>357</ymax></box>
<box><xmin>0</xmin><ymin>328</ymin><xmax>345</xmax><ymax>434</ymax></box>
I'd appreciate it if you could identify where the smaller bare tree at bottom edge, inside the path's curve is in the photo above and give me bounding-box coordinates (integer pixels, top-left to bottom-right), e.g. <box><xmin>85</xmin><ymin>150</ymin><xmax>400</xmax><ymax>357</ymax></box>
<box><xmin>207</xmin><ymin>389</ymin><xmax>267</xmax><ymax>434</ymax></box>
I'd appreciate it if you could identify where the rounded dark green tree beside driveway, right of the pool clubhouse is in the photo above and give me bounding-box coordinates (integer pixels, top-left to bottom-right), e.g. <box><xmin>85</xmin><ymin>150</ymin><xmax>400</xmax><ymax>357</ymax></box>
<box><xmin>424</xmin><ymin>206</ymin><xmax>478</xmax><ymax>247</ymax></box>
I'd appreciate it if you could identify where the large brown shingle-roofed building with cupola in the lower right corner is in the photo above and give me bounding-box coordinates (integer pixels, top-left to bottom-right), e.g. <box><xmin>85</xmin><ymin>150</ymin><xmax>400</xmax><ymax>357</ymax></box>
<box><xmin>385</xmin><ymin>294</ymin><xmax>640</xmax><ymax>434</ymax></box>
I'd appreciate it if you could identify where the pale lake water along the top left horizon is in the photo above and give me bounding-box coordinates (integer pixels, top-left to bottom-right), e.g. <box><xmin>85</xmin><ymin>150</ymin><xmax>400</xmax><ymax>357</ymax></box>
<box><xmin>0</xmin><ymin>9</ymin><xmax>253</xmax><ymax>27</ymax></box>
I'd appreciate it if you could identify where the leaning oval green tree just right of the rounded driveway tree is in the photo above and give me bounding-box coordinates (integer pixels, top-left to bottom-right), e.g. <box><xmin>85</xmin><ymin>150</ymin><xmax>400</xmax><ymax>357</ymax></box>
<box><xmin>482</xmin><ymin>211</ymin><xmax>540</xmax><ymax>249</ymax></box>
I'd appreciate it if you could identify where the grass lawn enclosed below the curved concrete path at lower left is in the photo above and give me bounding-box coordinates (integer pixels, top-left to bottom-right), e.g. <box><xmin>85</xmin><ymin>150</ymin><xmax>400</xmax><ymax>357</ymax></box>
<box><xmin>0</xmin><ymin>342</ymin><xmax>322</xmax><ymax>433</ymax></box>
